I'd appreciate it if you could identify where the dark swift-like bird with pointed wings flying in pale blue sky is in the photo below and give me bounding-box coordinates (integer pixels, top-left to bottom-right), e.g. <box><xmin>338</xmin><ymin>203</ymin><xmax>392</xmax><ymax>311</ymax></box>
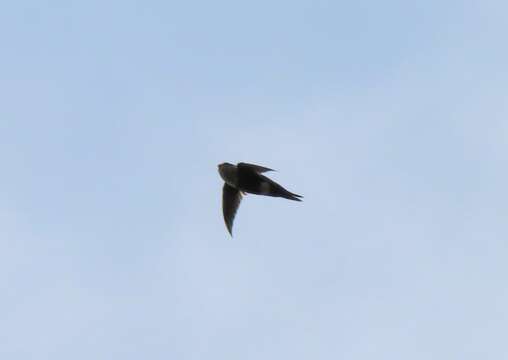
<box><xmin>218</xmin><ymin>162</ymin><xmax>303</xmax><ymax>236</ymax></box>
